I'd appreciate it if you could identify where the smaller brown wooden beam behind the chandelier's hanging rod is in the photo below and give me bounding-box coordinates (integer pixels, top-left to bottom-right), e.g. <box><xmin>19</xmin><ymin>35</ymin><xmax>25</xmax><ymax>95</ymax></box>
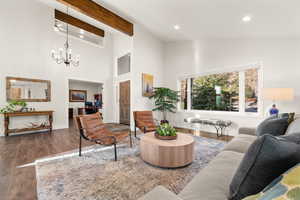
<box><xmin>54</xmin><ymin>9</ymin><xmax>105</xmax><ymax>37</ymax></box>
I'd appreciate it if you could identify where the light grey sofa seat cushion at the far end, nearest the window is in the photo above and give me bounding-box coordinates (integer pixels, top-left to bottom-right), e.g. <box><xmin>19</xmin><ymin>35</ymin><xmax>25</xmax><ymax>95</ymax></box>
<box><xmin>224</xmin><ymin>134</ymin><xmax>257</xmax><ymax>153</ymax></box>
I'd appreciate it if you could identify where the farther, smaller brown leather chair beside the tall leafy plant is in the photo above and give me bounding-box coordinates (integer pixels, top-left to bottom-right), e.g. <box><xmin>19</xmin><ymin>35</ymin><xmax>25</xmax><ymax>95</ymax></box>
<box><xmin>133</xmin><ymin>111</ymin><xmax>157</xmax><ymax>137</ymax></box>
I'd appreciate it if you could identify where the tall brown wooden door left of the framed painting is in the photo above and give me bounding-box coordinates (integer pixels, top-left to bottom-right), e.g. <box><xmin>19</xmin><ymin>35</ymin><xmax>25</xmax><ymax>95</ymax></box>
<box><xmin>119</xmin><ymin>81</ymin><xmax>130</xmax><ymax>125</ymax></box>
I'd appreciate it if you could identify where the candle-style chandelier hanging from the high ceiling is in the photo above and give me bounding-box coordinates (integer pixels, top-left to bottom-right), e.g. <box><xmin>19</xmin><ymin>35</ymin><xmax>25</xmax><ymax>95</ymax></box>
<box><xmin>51</xmin><ymin>8</ymin><xmax>80</xmax><ymax>67</ymax></box>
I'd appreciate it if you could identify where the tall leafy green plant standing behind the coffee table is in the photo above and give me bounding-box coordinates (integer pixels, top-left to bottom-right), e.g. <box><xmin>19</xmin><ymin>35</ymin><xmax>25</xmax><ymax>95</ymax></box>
<box><xmin>149</xmin><ymin>87</ymin><xmax>179</xmax><ymax>124</ymax></box>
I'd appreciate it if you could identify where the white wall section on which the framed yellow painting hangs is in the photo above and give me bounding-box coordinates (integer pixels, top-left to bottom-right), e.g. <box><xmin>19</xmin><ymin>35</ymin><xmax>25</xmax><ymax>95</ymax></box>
<box><xmin>132</xmin><ymin>26</ymin><xmax>164</xmax><ymax>119</ymax></box>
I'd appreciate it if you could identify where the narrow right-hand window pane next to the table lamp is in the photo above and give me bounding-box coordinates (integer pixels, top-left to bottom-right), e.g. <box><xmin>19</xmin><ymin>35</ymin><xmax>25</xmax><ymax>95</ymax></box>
<box><xmin>245</xmin><ymin>69</ymin><xmax>258</xmax><ymax>112</ymax></box>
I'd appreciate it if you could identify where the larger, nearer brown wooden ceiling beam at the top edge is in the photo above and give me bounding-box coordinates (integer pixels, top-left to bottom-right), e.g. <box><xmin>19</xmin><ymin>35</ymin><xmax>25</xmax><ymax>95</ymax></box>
<box><xmin>57</xmin><ymin>0</ymin><xmax>134</xmax><ymax>36</ymax></box>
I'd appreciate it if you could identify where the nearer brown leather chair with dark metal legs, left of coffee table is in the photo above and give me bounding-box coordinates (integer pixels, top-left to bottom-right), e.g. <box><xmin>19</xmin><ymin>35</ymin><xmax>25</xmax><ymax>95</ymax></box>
<box><xmin>74</xmin><ymin>113</ymin><xmax>132</xmax><ymax>160</ymax></box>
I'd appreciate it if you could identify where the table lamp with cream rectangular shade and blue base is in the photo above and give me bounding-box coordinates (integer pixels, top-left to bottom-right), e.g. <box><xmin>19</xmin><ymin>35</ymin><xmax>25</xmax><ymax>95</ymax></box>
<box><xmin>263</xmin><ymin>88</ymin><xmax>294</xmax><ymax>115</ymax></box>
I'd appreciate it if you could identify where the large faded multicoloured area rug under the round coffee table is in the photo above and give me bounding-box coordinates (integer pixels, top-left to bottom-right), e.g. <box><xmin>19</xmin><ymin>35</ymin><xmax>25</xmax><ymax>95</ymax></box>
<box><xmin>36</xmin><ymin>136</ymin><xmax>225</xmax><ymax>200</ymax></box>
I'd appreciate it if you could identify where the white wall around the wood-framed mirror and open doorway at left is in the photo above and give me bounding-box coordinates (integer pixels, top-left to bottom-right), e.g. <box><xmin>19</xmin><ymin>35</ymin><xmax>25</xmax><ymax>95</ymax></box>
<box><xmin>0</xmin><ymin>0</ymin><xmax>113</xmax><ymax>135</ymax></box>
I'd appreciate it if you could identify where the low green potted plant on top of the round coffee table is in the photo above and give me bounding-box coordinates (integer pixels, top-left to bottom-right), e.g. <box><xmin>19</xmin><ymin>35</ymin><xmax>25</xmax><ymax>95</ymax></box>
<box><xmin>155</xmin><ymin>123</ymin><xmax>177</xmax><ymax>140</ymax></box>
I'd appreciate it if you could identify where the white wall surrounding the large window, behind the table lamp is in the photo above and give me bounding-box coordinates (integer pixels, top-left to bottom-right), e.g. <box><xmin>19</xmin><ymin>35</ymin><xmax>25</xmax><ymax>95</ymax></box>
<box><xmin>164</xmin><ymin>39</ymin><xmax>300</xmax><ymax>134</ymax></box>
